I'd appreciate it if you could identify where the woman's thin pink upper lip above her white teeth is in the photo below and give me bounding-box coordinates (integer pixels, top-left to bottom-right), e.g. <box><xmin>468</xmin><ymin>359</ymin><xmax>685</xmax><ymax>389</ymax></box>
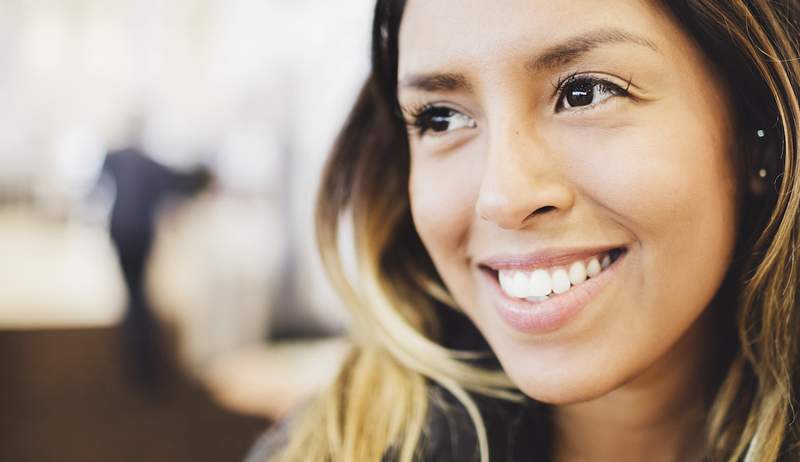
<box><xmin>478</xmin><ymin>245</ymin><xmax>625</xmax><ymax>271</ymax></box>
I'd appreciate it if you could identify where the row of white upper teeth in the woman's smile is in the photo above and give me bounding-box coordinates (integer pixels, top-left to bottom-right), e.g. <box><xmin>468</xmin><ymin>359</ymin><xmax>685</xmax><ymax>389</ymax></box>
<box><xmin>498</xmin><ymin>254</ymin><xmax>611</xmax><ymax>302</ymax></box>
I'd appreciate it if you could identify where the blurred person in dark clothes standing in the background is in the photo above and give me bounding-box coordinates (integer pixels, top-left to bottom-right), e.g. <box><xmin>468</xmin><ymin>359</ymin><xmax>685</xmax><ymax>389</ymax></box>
<box><xmin>103</xmin><ymin>148</ymin><xmax>209</xmax><ymax>386</ymax></box>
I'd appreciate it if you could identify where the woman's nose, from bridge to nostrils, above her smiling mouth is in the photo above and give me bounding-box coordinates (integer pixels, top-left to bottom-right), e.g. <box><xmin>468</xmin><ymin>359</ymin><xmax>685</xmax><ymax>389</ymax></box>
<box><xmin>475</xmin><ymin>127</ymin><xmax>575</xmax><ymax>229</ymax></box>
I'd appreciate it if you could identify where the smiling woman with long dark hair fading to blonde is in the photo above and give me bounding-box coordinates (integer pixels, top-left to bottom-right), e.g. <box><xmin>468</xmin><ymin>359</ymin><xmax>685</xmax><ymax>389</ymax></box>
<box><xmin>253</xmin><ymin>0</ymin><xmax>800</xmax><ymax>461</ymax></box>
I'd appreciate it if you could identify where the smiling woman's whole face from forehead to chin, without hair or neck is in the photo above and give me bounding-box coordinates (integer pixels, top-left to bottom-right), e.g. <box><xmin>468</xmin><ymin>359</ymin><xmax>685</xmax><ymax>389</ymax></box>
<box><xmin>398</xmin><ymin>0</ymin><xmax>736</xmax><ymax>403</ymax></box>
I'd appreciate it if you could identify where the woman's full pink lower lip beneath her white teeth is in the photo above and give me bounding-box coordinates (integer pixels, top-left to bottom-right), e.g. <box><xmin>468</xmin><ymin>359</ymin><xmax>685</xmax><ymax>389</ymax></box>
<box><xmin>484</xmin><ymin>252</ymin><xmax>628</xmax><ymax>334</ymax></box>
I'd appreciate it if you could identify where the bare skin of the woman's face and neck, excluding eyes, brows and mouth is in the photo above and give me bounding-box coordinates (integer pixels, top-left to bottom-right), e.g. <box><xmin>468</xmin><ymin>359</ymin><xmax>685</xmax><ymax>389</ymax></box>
<box><xmin>398</xmin><ymin>0</ymin><xmax>737</xmax><ymax>461</ymax></box>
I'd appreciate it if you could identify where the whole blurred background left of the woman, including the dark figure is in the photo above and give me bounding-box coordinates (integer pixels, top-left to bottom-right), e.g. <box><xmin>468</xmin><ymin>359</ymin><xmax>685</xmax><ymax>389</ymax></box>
<box><xmin>0</xmin><ymin>0</ymin><xmax>373</xmax><ymax>462</ymax></box>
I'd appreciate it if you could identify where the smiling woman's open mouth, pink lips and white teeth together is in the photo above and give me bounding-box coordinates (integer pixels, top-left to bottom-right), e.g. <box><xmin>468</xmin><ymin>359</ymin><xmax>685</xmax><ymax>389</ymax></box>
<box><xmin>478</xmin><ymin>247</ymin><xmax>627</xmax><ymax>333</ymax></box>
